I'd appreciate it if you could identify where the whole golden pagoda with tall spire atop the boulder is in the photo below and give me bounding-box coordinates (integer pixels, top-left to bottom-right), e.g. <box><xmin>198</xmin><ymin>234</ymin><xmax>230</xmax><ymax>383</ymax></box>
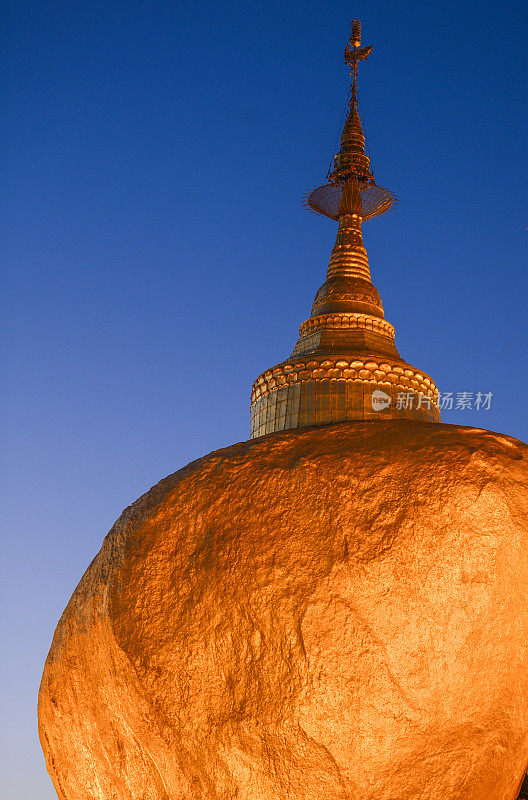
<box><xmin>251</xmin><ymin>20</ymin><xmax>440</xmax><ymax>438</ymax></box>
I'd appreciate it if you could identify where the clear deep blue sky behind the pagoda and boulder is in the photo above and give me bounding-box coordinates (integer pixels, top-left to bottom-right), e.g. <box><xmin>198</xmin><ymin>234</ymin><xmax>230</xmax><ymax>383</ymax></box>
<box><xmin>0</xmin><ymin>0</ymin><xmax>528</xmax><ymax>800</ymax></box>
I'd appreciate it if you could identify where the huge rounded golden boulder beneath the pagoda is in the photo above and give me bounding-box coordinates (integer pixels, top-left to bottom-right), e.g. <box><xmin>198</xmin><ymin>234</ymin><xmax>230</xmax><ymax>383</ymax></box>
<box><xmin>39</xmin><ymin>421</ymin><xmax>528</xmax><ymax>800</ymax></box>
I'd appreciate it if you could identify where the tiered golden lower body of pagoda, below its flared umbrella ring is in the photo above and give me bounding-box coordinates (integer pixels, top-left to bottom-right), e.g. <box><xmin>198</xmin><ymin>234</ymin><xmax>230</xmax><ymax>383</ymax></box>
<box><xmin>251</xmin><ymin>214</ymin><xmax>440</xmax><ymax>438</ymax></box>
